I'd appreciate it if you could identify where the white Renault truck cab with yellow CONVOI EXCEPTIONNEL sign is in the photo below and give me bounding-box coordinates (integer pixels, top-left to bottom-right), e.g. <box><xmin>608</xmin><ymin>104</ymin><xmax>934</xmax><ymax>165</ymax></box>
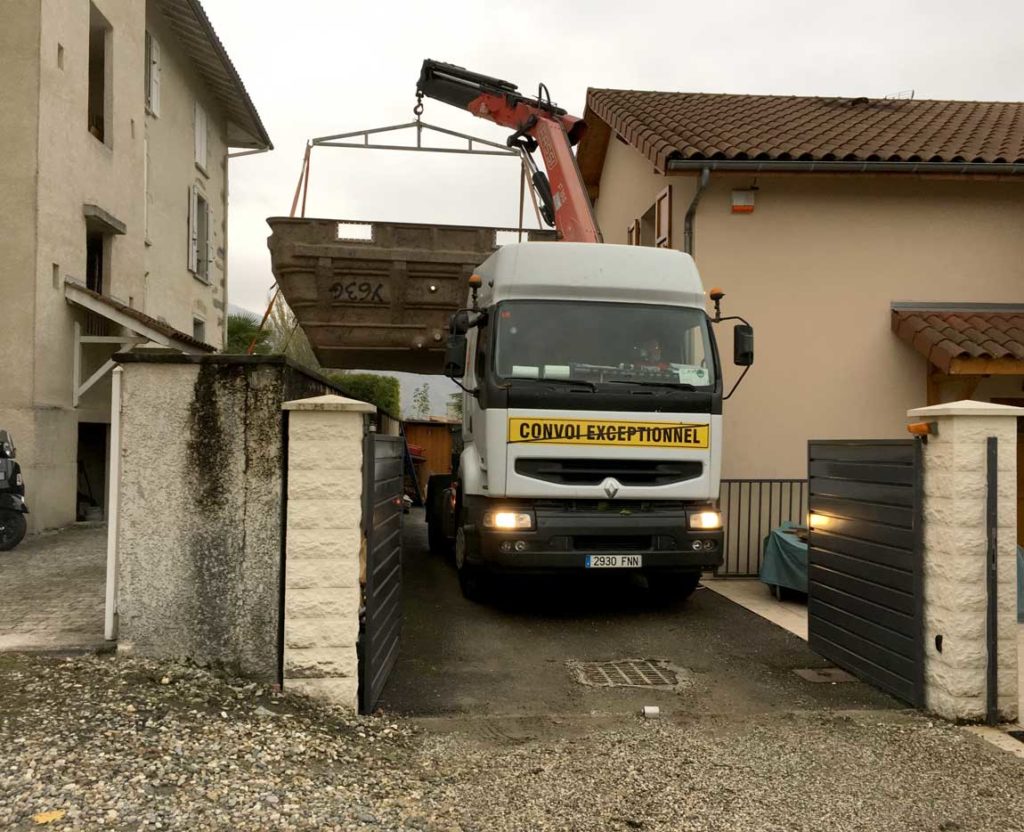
<box><xmin>428</xmin><ymin>242</ymin><xmax>753</xmax><ymax>597</ymax></box>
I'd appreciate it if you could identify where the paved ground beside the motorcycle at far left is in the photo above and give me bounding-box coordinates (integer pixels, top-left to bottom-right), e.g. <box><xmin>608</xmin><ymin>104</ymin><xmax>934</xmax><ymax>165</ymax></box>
<box><xmin>0</xmin><ymin>524</ymin><xmax>106</xmax><ymax>652</ymax></box>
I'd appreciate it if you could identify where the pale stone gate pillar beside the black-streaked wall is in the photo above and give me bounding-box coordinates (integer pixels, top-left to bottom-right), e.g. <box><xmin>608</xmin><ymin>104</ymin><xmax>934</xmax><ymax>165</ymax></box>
<box><xmin>283</xmin><ymin>396</ymin><xmax>377</xmax><ymax>712</ymax></box>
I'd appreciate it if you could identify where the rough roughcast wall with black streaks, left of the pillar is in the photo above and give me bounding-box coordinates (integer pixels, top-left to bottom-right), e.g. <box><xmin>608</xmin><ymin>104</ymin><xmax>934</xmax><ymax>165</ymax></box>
<box><xmin>117</xmin><ymin>353</ymin><xmax>329</xmax><ymax>682</ymax></box>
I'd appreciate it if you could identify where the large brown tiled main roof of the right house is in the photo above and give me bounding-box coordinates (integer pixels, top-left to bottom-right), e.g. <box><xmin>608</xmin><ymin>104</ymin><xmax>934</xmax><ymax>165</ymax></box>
<box><xmin>585</xmin><ymin>89</ymin><xmax>1024</xmax><ymax>170</ymax></box>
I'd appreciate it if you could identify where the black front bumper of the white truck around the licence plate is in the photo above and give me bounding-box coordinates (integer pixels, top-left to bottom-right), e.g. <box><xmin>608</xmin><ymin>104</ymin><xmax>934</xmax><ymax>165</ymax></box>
<box><xmin>466</xmin><ymin>500</ymin><xmax>724</xmax><ymax>573</ymax></box>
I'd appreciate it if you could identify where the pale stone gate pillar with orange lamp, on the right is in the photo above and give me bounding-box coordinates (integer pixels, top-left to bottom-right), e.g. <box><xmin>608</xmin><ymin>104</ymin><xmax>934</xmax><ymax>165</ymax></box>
<box><xmin>907</xmin><ymin>402</ymin><xmax>1024</xmax><ymax>721</ymax></box>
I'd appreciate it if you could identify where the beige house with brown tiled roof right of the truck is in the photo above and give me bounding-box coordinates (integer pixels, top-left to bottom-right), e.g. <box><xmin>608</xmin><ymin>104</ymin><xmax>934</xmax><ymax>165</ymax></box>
<box><xmin>578</xmin><ymin>89</ymin><xmax>1024</xmax><ymax>553</ymax></box>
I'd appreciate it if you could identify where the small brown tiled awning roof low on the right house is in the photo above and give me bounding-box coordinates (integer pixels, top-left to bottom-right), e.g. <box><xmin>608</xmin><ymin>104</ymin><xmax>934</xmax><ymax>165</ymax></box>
<box><xmin>892</xmin><ymin>304</ymin><xmax>1024</xmax><ymax>373</ymax></box>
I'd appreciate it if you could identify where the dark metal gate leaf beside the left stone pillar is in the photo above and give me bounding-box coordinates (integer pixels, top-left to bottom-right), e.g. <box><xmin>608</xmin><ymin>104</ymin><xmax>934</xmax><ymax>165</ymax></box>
<box><xmin>359</xmin><ymin>433</ymin><xmax>406</xmax><ymax>713</ymax></box>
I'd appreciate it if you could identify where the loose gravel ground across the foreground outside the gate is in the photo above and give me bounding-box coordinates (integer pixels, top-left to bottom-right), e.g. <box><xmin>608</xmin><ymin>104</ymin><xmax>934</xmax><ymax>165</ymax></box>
<box><xmin>0</xmin><ymin>655</ymin><xmax>1024</xmax><ymax>832</ymax></box>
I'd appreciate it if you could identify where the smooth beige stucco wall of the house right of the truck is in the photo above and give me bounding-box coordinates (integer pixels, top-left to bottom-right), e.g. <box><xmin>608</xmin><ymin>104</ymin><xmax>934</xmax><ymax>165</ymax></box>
<box><xmin>597</xmin><ymin>138</ymin><xmax>1024</xmax><ymax>477</ymax></box>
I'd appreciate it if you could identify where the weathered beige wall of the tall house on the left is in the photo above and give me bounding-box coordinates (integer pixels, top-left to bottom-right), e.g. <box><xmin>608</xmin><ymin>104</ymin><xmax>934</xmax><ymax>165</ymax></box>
<box><xmin>0</xmin><ymin>0</ymin><xmax>235</xmax><ymax>531</ymax></box>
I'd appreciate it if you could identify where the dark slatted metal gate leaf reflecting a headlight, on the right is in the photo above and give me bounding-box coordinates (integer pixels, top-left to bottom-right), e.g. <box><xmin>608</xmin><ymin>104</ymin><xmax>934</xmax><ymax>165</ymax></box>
<box><xmin>808</xmin><ymin>440</ymin><xmax>924</xmax><ymax>706</ymax></box>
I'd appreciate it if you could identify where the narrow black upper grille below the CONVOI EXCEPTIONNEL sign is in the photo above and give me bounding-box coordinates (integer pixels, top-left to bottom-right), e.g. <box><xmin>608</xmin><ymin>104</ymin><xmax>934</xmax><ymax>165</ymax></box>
<box><xmin>515</xmin><ymin>458</ymin><xmax>703</xmax><ymax>486</ymax></box>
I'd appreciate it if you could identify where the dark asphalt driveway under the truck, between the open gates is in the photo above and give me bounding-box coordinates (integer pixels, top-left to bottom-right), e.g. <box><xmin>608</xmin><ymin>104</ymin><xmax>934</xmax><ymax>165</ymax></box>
<box><xmin>380</xmin><ymin>512</ymin><xmax>902</xmax><ymax>718</ymax></box>
